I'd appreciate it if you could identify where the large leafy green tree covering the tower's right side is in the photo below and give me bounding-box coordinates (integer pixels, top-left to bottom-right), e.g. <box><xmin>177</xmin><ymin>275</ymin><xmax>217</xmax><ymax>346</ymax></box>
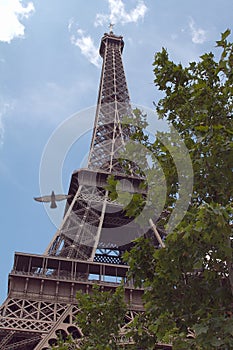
<box><xmin>126</xmin><ymin>30</ymin><xmax>233</xmax><ymax>350</ymax></box>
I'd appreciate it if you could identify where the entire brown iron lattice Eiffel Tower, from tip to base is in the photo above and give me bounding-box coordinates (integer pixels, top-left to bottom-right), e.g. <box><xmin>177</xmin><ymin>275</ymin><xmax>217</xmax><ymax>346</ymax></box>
<box><xmin>0</xmin><ymin>28</ymin><xmax>169</xmax><ymax>350</ymax></box>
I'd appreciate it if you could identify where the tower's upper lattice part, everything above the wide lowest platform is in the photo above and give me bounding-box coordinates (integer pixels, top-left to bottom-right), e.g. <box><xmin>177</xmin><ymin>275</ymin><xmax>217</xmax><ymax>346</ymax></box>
<box><xmin>46</xmin><ymin>32</ymin><xmax>146</xmax><ymax>263</ymax></box>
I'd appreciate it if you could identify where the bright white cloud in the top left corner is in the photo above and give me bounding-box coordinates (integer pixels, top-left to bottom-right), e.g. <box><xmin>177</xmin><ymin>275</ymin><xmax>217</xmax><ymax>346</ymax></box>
<box><xmin>0</xmin><ymin>0</ymin><xmax>35</xmax><ymax>43</ymax></box>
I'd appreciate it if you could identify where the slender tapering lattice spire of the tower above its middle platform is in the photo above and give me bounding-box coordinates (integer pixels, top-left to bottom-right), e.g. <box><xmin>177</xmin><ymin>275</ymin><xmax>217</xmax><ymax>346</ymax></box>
<box><xmin>88</xmin><ymin>34</ymin><xmax>132</xmax><ymax>174</ymax></box>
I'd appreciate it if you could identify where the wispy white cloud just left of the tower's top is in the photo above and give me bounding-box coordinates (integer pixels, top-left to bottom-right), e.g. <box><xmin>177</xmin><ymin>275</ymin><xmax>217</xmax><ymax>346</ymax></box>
<box><xmin>68</xmin><ymin>24</ymin><xmax>100</xmax><ymax>67</ymax></box>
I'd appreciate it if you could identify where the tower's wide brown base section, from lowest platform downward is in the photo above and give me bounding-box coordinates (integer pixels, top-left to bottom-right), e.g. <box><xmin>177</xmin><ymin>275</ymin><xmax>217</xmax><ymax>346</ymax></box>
<box><xmin>0</xmin><ymin>253</ymin><xmax>143</xmax><ymax>350</ymax></box>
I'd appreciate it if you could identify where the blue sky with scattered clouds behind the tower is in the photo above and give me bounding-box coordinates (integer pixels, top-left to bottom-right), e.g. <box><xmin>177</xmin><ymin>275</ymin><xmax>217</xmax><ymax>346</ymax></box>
<box><xmin>0</xmin><ymin>0</ymin><xmax>233</xmax><ymax>301</ymax></box>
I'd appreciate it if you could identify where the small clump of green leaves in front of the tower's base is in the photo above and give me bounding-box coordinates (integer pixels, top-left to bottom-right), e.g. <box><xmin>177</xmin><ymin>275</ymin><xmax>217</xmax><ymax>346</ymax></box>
<box><xmin>74</xmin><ymin>285</ymin><xmax>127</xmax><ymax>350</ymax></box>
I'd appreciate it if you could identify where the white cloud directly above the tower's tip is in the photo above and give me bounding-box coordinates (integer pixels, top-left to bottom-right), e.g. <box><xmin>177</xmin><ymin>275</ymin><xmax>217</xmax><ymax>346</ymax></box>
<box><xmin>95</xmin><ymin>0</ymin><xmax>147</xmax><ymax>26</ymax></box>
